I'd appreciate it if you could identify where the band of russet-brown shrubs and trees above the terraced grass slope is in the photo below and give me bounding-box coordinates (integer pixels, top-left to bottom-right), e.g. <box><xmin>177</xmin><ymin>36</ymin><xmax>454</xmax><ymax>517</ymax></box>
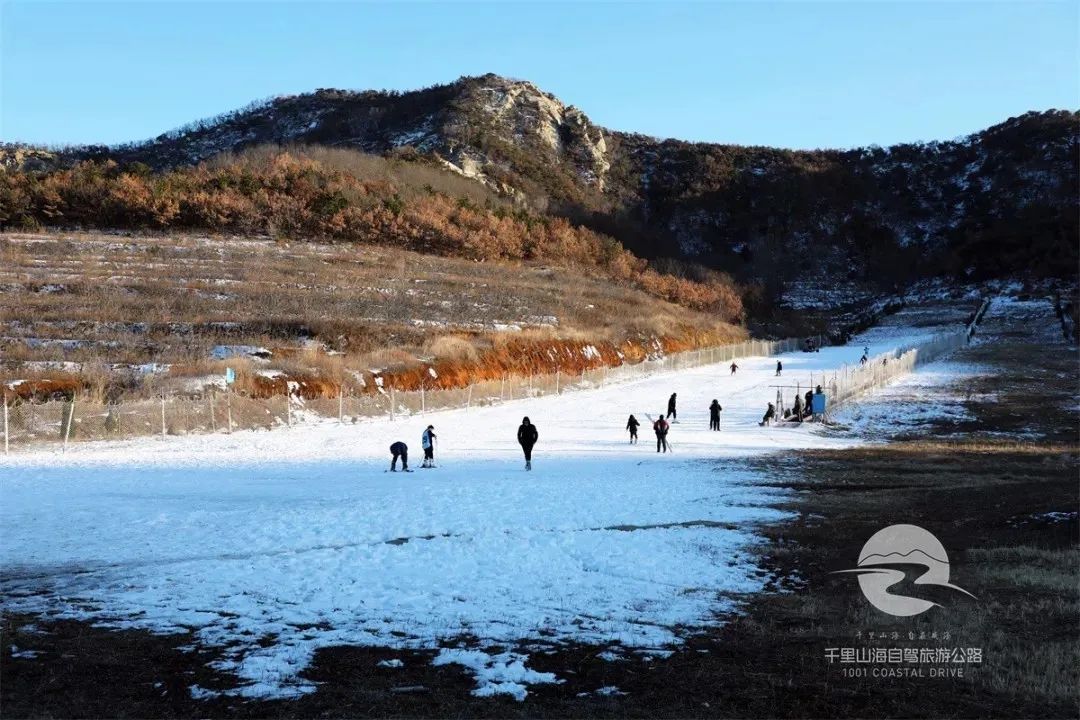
<box><xmin>0</xmin><ymin>148</ymin><xmax>742</xmax><ymax>322</ymax></box>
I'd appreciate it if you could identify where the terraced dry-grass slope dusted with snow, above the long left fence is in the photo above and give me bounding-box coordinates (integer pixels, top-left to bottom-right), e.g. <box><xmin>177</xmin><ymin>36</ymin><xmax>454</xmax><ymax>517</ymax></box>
<box><xmin>0</xmin><ymin>232</ymin><xmax>746</xmax><ymax>397</ymax></box>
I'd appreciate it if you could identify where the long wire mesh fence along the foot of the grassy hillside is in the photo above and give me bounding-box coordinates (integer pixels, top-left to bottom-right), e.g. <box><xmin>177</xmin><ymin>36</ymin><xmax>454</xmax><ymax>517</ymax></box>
<box><xmin>3</xmin><ymin>338</ymin><xmax>846</xmax><ymax>452</ymax></box>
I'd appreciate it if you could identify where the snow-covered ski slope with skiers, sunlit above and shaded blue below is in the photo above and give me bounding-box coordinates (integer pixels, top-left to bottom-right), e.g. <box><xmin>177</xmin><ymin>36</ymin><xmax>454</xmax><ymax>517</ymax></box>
<box><xmin>0</xmin><ymin>321</ymin><xmax>963</xmax><ymax>696</ymax></box>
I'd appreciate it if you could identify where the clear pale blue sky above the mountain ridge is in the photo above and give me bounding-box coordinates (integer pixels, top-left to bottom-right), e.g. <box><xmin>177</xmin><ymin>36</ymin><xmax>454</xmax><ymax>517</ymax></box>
<box><xmin>0</xmin><ymin>0</ymin><xmax>1080</xmax><ymax>148</ymax></box>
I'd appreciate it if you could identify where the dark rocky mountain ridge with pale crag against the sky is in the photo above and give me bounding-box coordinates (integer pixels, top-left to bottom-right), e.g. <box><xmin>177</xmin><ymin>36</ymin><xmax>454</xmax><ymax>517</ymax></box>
<box><xmin>0</xmin><ymin>74</ymin><xmax>1080</xmax><ymax>287</ymax></box>
